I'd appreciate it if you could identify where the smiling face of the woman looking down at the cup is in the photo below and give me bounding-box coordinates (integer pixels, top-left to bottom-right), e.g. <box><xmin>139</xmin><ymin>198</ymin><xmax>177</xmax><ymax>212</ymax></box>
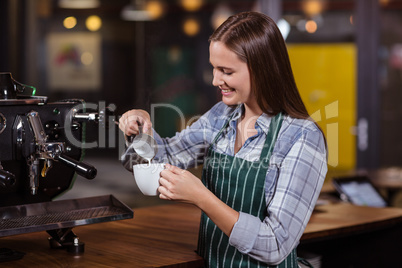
<box><xmin>209</xmin><ymin>41</ymin><xmax>256</xmax><ymax>109</ymax></box>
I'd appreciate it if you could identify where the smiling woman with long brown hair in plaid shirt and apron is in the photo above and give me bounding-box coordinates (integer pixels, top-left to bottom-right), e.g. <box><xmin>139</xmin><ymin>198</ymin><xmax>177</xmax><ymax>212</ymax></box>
<box><xmin>120</xmin><ymin>12</ymin><xmax>327</xmax><ymax>267</ymax></box>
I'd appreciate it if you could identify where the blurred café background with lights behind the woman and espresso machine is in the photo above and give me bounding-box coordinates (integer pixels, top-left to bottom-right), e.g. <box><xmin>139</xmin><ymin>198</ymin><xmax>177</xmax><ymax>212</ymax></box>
<box><xmin>0</xmin><ymin>0</ymin><xmax>402</xmax><ymax>207</ymax></box>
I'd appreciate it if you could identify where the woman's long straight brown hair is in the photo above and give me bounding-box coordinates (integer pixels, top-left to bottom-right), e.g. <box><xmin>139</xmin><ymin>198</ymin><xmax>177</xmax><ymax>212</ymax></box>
<box><xmin>209</xmin><ymin>12</ymin><xmax>309</xmax><ymax>119</ymax></box>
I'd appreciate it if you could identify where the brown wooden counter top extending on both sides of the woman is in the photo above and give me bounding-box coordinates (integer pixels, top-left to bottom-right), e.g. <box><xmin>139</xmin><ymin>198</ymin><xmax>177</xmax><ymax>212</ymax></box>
<box><xmin>0</xmin><ymin>203</ymin><xmax>402</xmax><ymax>268</ymax></box>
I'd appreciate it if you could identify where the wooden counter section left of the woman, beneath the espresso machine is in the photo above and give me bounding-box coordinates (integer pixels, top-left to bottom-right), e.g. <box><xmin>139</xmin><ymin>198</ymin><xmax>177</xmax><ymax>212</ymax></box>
<box><xmin>0</xmin><ymin>203</ymin><xmax>203</xmax><ymax>268</ymax></box>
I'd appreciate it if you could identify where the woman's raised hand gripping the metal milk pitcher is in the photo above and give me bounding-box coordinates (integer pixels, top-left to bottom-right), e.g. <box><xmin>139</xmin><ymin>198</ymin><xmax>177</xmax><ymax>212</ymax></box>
<box><xmin>119</xmin><ymin>110</ymin><xmax>152</xmax><ymax>136</ymax></box>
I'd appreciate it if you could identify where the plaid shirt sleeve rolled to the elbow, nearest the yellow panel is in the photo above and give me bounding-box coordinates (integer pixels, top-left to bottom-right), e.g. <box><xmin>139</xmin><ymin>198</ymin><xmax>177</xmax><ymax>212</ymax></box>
<box><xmin>229</xmin><ymin>126</ymin><xmax>327</xmax><ymax>264</ymax></box>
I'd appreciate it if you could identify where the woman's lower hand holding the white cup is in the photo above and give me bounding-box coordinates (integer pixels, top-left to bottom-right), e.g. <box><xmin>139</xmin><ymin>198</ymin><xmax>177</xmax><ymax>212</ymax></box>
<box><xmin>158</xmin><ymin>164</ymin><xmax>208</xmax><ymax>205</ymax></box>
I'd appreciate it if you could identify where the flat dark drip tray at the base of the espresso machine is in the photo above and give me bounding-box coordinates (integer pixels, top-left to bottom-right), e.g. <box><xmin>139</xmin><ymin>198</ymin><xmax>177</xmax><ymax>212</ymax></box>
<box><xmin>0</xmin><ymin>195</ymin><xmax>134</xmax><ymax>237</ymax></box>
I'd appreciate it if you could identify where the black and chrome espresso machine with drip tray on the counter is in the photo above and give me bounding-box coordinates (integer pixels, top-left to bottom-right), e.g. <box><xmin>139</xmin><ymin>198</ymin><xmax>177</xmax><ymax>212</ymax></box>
<box><xmin>0</xmin><ymin>73</ymin><xmax>133</xmax><ymax>258</ymax></box>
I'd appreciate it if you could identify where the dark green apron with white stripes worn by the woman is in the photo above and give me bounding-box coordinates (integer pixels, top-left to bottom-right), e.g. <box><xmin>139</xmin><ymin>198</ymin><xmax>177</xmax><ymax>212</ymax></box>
<box><xmin>198</xmin><ymin>114</ymin><xmax>298</xmax><ymax>268</ymax></box>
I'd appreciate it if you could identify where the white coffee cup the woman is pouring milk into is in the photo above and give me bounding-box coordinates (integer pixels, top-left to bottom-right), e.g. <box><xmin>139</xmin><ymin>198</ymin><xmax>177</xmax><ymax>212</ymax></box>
<box><xmin>133</xmin><ymin>163</ymin><xmax>165</xmax><ymax>195</ymax></box>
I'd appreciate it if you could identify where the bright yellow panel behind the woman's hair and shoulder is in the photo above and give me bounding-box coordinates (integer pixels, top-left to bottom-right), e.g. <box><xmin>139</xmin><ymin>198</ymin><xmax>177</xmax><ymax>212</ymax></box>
<box><xmin>288</xmin><ymin>43</ymin><xmax>357</xmax><ymax>170</ymax></box>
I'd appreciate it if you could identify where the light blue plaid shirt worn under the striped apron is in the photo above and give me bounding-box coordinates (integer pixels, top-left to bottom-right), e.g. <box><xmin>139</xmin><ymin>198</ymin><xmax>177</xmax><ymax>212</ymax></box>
<box><xmin>154</xmin><ymin>102</ymin><xmax>327</xmax><ymax>264</ymax></box>
